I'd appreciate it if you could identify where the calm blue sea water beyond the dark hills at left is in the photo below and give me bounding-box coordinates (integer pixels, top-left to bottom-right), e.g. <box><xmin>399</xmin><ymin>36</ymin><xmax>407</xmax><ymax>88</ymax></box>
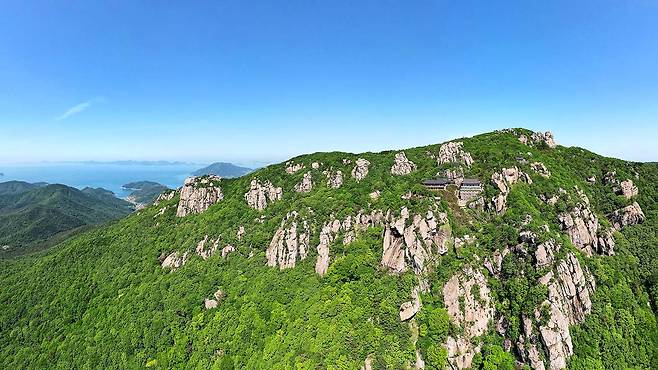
<box><xmin>0</xmin><ymin>163</ymin><xmax>204</xmax><ymax>198</ymax></box>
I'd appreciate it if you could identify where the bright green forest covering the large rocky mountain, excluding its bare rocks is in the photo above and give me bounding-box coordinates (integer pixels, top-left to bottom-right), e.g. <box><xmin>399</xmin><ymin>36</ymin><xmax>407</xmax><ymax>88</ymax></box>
<box><xmin>0</xmin><ymin>131</ymin><xmax>658</xmax><ymax>369</ymax></box>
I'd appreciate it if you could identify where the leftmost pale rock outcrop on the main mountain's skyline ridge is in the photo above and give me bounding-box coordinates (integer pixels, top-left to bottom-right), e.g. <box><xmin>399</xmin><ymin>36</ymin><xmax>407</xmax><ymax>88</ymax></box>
<box><xmin>176</xmin><ymin>175</ymin><xmax>224</xmax><ymax>217</ymax></box>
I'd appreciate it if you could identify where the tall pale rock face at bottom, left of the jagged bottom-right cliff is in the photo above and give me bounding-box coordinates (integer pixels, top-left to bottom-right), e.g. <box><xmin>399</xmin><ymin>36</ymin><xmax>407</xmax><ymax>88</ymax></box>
<box><xmin>443</xmin><ymin>267</ymin><xmax>494</xmax><ymax>369</ymax></box>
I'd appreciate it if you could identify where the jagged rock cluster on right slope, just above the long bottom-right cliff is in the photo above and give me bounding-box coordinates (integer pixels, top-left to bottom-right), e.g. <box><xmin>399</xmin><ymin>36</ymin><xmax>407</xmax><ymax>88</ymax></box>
<box><xmin>558</xmin><ymin>202</ymin><xmax>615</xmax><ymax>257</ymax></box>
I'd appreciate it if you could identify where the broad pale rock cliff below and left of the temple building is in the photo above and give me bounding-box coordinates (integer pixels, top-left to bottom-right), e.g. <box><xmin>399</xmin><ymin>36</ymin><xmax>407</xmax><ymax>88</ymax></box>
<box><xmin>381</xmin><ymin>207</ymin><xmax>452</xmax><ymax>274</ymax></box>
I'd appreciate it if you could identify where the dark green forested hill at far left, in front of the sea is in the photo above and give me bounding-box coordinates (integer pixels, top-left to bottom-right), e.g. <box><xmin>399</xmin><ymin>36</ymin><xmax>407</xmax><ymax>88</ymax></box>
<box><xmin>0</xmin><ymin>181</ymin><xmax>132</xmax><ymax>257</ymax></box>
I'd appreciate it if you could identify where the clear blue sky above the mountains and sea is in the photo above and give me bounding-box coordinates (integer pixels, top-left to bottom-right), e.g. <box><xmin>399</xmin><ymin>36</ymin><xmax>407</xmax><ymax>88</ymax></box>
<box><xmin>0</xmin><ymin>0</ymin><xmax>658</xmax><ymax>162</ymax></box>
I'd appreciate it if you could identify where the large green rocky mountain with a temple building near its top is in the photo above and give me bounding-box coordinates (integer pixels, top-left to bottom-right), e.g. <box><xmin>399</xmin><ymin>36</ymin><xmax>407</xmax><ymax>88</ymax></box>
<box><xmin>0</xmin><ymin>129</ymin><xmax>658</xmax><ymax>369</ymax></box>
